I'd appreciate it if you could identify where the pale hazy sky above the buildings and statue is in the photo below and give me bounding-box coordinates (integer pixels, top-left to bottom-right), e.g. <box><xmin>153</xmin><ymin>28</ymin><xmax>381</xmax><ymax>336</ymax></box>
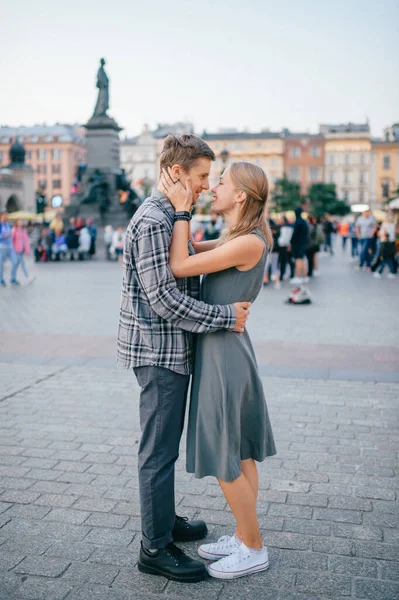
<box><xmin>0</xmin><ymin>0</ymin><xmax>399</xmax><ymax>137</ymax></box>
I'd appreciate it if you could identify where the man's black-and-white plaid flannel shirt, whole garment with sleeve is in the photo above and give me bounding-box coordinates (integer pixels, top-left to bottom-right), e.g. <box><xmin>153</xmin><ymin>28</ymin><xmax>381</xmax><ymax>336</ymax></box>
<box><xmin>117</xmin><ymin>190</ymin><xmax>236</xmax><ymax>375</ymax></box>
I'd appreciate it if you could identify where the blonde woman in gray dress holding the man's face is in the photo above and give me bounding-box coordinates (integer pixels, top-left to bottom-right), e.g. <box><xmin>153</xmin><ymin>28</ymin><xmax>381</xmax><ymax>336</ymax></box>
<box><xmin>162</xmin><ymin>162</ymin><xmax>276</xmax><ymax>579</ymax></box>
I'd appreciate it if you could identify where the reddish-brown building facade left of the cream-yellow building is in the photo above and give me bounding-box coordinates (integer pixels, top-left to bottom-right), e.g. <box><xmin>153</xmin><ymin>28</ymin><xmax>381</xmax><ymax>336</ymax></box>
<box><xmin>284</xmin><ymin>130</ymin><xmax>325</xmax><ymax>195</ymax></box>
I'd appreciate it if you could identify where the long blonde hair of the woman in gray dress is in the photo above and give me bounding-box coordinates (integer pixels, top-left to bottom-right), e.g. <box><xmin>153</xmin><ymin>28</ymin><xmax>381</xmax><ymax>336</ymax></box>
<box><xmin>219</xmin><ymin>161</ymin><xmax>273</xmax><ymax>251</ymax></box>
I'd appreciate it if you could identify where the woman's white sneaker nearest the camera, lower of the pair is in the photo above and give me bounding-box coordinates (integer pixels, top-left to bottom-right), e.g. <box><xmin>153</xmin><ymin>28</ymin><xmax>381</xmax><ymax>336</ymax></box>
<box><xmin>208</xmin><ymin>544</ymin><xmax>269</xmax><ymax>579</ymax></box>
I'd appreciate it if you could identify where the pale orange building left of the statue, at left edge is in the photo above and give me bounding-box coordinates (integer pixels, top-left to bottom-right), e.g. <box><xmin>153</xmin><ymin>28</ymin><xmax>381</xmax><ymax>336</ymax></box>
<box><xmin>0</xmin><ymin>125</ymin><xmax>86</xmax><ymax>206</ymax></box>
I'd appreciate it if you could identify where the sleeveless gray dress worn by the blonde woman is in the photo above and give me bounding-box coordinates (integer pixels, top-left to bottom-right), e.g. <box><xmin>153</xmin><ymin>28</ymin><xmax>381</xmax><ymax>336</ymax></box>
<box><xmin>187</xmin><ymin>230</ymin><xmax>276</xmax><ymax>481</ymax></box>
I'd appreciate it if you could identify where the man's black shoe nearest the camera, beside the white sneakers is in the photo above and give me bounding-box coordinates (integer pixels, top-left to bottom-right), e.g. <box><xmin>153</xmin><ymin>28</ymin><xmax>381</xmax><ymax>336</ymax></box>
<box><xmin>137</xmin><ymin>543</ymin><xmax>208</xmax><ymax>583</ymax></box>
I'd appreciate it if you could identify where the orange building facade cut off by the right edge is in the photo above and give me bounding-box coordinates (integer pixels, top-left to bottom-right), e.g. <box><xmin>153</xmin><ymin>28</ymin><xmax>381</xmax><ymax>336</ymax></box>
<box><xmin>370</xmin><ymin>123</ymin><xmax>399</xmax><ymax>208</ymax></box>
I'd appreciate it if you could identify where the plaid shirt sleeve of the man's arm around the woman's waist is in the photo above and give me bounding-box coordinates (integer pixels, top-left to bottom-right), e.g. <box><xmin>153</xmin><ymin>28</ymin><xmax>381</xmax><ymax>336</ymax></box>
<box><xmin>132</xmin><ymin>222</ymin><xmax>236</xmax><ymax>333</ymax></box>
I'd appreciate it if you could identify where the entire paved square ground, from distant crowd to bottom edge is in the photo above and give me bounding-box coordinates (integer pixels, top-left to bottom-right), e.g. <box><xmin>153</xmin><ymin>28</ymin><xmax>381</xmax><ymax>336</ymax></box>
<box><xmin>0</xmin><ymin>246</ymin><xmax>399</xmax><ymax>600</ymax></box>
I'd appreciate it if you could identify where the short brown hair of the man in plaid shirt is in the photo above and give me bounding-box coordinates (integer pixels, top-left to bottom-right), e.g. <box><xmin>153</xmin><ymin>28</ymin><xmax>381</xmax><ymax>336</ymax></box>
<box><xmin>160</xmin><ymin>134</ymin><xmax>215</xmax><ymax>172</ymax></box>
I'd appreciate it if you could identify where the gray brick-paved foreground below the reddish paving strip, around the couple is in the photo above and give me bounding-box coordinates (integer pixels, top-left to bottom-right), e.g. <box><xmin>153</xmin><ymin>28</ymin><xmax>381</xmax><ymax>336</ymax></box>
<box><xmin>0</xmin><ymin>364</ymin><xmax>399</xmax><ymax>600</ymax></box>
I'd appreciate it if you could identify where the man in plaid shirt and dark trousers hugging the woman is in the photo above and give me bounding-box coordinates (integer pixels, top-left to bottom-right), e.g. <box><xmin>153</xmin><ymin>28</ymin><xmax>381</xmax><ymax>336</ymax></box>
<box><xmin>118</xmin><ymin>135</ymin><xmax>249</xmax><ymax>582</ymax></box>
